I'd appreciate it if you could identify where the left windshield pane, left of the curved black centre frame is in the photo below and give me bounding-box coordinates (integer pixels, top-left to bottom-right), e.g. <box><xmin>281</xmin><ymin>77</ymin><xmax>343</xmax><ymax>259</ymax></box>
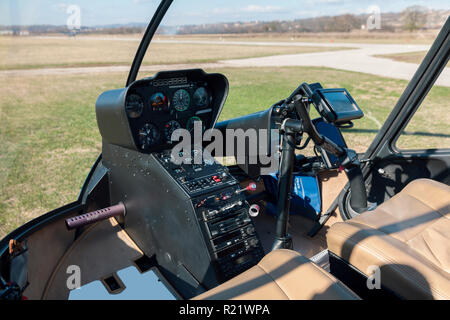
<box><xmin>0</xmin><ymin>0</ymin><xmax>158</xmax><ymax>238</ymax></box>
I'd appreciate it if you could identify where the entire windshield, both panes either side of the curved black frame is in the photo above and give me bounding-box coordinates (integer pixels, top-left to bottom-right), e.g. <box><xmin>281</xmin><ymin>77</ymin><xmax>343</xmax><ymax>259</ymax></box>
<box><xmin>0</xmin><ymin>0</ymin><xmax>450</xmax><ymax>237</ymax></box>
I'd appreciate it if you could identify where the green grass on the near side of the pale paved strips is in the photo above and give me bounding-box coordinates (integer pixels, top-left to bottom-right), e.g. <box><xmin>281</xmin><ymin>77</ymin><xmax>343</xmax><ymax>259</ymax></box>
<box><xmin>0</xmin><ymin>68</ymin><xmax>450</xmax><ymax>237</ymax></box>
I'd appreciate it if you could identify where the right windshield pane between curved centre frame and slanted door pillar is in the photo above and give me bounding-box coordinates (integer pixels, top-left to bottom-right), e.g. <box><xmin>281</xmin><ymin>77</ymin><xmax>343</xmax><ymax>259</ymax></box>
<box><xmin>138</xmin><ymin>0</ymin><xmax>450</xmax><ymax>154</ymax></box>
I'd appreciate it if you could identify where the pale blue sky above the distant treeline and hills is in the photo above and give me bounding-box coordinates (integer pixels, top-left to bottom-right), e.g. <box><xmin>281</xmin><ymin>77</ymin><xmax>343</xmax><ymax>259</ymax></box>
<box><xmin>0</xmin><ymin>0</ymin><xmax>450</xmax><ymax>26</ymax></box>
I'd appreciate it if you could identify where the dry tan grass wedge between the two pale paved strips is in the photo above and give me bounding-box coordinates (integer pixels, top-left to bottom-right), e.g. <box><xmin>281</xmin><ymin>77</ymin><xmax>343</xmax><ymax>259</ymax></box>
<box><xmin>0</xmin><ymin>37</ymin><xmax>348</xmax><ymax>70</ymax></box>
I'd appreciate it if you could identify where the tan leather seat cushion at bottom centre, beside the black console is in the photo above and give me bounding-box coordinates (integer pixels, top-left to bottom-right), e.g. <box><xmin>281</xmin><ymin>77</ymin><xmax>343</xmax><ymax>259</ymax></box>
<box><xmin>194</xmin><ymin>249</ymin><xmax>359</xmax><ymax>300</ymax></box>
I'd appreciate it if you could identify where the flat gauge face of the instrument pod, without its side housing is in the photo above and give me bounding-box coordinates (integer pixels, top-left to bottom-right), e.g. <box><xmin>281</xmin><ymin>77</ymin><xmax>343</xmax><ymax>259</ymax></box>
<box><xmin>125</xmin><ymin>69</ymin><xmax>228</xmax><ymax>152</ymax></box>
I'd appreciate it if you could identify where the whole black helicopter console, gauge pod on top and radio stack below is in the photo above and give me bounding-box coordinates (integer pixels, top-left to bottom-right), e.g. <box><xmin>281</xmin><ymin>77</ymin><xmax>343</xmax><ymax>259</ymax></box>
<box><xmin>96</xmin><ymin>69</ymin><xmax>264</xmax><ymax>298</ymax></box>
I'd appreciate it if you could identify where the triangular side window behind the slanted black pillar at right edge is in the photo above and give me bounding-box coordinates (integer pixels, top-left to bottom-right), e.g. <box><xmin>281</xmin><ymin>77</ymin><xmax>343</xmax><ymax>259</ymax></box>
<box><xmin>396</xmin><ymin>67</ymin><xmax>450</xmax><ymax>150</ymax></box>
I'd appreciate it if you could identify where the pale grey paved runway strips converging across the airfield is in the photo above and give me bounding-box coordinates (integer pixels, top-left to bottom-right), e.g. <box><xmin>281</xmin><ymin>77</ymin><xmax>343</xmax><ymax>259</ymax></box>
<box><xmin>0</xmin><ymin>37</ymin><xmax>450</xmax><ymax>87</ymax></box>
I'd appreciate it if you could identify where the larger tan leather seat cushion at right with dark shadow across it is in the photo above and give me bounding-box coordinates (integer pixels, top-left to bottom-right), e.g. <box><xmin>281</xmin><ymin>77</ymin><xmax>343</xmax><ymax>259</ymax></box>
<box><xmin>327</xmin><ymin>179</ymin><xmax>450</xmax><ymax>299</ymax></box>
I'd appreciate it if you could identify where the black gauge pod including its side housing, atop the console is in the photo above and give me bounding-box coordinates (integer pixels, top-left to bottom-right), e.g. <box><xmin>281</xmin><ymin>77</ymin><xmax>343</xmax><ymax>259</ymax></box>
<box><xmin>96</xmin><ymin>69</ymin><xmax>228</xmax><ymax>153</ymax></box>
